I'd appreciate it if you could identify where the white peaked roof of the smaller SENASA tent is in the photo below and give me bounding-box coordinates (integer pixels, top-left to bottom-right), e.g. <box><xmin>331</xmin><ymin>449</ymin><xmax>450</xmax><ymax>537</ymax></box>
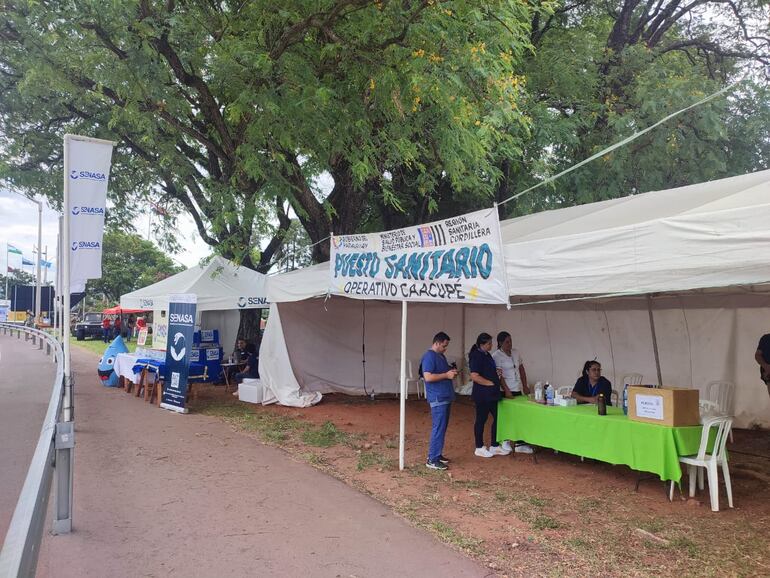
<box><xmin>120</xmin><ymin>256</ymin><xmax>269</xmax><ymax>311</ymax></box>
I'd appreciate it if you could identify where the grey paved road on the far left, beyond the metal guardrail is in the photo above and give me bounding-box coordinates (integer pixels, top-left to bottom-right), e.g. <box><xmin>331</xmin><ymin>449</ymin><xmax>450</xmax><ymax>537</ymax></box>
<box><xmin>0</xmin><ymin>331</ymin><xmax>55</xmax><ymax>545</ymax></box>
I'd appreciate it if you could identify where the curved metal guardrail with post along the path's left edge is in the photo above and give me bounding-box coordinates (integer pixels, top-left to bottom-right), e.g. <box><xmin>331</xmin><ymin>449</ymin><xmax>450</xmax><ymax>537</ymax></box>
<box><xmin>0</xmin><ymin>323</ymin><xmax>75</xmax><ymax>578</ymax></box>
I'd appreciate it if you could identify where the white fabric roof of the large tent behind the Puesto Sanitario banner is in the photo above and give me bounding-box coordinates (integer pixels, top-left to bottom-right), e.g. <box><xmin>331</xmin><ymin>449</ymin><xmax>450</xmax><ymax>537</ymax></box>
<box><xmin>267</xmin><ymin>170</ymin><xmax>770</xmax><ymax>303</ymax></box>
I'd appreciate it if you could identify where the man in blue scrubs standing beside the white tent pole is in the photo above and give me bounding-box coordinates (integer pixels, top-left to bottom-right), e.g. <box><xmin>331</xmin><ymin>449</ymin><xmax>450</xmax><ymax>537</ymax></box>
<box><xmin>420</xmin><ymin>331</ymin><xmax>457</xmax><ymax>470</ymax></box>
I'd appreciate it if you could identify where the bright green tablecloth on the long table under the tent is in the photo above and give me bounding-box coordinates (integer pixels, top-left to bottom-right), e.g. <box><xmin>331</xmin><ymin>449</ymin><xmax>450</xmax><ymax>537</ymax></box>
<box><xmin>497</xmin><ymin>397</ymin><xmax>702</xmax><ymax>482</ymax></box>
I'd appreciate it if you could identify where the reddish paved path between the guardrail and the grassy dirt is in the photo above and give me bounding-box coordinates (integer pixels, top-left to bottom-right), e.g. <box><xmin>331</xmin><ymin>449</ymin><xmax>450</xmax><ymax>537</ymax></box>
<box><xmin>38</xmin><ymin>347</ymin><xmax>488</xmax><ymax>578</ymax></box>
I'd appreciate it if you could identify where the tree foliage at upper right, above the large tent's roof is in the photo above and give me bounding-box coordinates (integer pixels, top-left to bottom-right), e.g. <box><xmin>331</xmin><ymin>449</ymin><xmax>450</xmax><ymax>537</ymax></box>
<box><xmin>498</xmin><ymin>0</ymin><xmax>770</xmax><ymax>213</ymax></box>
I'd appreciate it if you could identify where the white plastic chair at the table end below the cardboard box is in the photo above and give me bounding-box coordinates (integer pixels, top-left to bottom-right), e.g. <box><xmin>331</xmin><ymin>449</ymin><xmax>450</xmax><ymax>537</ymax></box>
<box><xmin>668</xmin><ymin>416</ymin><xmax>733</xmax><ymax>512</ymax></box>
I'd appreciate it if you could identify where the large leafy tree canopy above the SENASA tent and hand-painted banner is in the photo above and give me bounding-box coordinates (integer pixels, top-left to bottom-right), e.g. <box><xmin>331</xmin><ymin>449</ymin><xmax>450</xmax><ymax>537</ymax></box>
<box><xmin>0</xmin><ymin>0</ymin><xmax>533</xmax><ymax>260</ymax></box>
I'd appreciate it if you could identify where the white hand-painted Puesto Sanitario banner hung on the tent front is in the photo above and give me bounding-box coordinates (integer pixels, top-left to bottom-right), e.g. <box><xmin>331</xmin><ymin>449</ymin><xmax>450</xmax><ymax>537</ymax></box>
<box><xmin>330</xmin><ymin>209</ymin><xmax>508</xmax><ymax>303</ymax></box>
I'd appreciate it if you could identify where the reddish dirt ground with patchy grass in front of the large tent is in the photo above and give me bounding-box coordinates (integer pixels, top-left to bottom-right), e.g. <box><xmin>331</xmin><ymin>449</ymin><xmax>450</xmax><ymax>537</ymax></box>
<box><xmin>183</xmin><ymin>387</ymin><xmax>770</xmax><ymax>576</ymax></box>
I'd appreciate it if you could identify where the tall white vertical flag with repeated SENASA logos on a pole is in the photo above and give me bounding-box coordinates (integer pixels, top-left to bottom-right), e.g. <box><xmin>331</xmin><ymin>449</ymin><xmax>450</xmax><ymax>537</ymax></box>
<box><xmin>64</xmin><ymin>135</ymin><xmax>112</xmax><ymax>291</ymax></box>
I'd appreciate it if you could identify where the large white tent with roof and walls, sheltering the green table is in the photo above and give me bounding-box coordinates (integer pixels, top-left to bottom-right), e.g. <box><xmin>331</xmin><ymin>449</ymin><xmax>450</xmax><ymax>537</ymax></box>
<box><xmin>261</xmin><ymin>171</ymin><xmax>770</xmax><ymax>427</ymax></box>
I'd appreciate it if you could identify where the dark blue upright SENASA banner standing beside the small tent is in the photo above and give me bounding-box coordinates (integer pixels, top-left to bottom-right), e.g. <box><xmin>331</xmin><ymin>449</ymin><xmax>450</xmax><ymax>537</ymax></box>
<box><xmin>160</xmin><ymin>294</ymin><xmax>197</xmax><ymax>413</ymax></box>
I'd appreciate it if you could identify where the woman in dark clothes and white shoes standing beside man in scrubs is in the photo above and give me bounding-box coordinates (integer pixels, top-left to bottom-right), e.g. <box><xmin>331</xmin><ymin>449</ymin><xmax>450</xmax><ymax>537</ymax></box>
<box><xmin>468</xmin><ymin>333</ymin><xmax>511</xmax><ymax>458</ymax></box>
